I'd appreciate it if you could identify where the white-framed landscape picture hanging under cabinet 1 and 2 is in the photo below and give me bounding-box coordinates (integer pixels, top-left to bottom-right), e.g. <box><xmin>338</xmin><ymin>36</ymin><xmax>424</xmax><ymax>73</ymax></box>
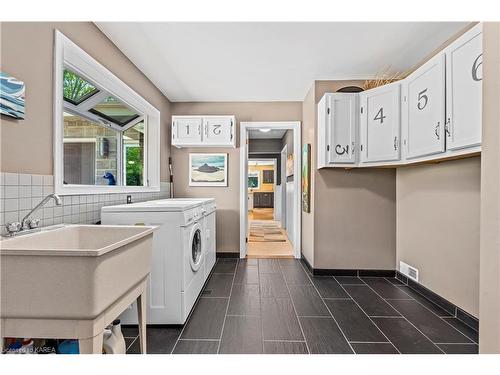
<box><xmin>189</xmin><ymin>154</ymin><xmax>227</xmax><ymax>186</ymax></box>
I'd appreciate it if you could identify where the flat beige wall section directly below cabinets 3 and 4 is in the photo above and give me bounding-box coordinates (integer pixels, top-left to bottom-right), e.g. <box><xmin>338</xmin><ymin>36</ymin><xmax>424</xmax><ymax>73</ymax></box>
<box><xmin>314</xmin><ymin>168</ymin><xmax>396</xmax><ymax>270</ymax></box>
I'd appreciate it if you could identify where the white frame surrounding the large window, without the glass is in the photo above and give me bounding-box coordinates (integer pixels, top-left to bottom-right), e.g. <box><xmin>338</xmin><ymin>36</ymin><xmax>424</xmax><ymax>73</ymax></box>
<box><xmin>53</xmin><ymin>30</ymin><xmax>160</xmax><ymax>195</ymax></box>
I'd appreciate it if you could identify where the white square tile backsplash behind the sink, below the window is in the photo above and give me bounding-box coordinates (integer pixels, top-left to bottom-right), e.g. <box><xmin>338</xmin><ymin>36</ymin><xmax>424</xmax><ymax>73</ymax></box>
<box><xmin>0</xmin><ymin>173</ymin><xmax>170</xmax><ymax>234</ymax></box>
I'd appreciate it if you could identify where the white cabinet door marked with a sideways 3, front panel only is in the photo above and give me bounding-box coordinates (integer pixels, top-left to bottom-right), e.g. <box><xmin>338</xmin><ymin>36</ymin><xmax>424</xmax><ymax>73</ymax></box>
<box><xmin>327</xmin><ymin>94</ymin><xmax>357</xmax><ymax>164</ymax></box>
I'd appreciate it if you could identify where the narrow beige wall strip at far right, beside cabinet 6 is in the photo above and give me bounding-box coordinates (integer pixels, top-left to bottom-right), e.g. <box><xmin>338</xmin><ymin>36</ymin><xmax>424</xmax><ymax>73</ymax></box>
<box><xmin>479</xmin><ymin>23</ymin><xmax>500</xmax><ymax>354</ymax></box>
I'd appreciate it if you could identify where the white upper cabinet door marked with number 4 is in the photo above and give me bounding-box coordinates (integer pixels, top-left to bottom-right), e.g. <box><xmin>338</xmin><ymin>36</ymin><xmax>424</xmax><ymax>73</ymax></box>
<box><xmin>359</xmin><ymin>82</ymin><xmax>401</xmax><ymax>163</ymax></box>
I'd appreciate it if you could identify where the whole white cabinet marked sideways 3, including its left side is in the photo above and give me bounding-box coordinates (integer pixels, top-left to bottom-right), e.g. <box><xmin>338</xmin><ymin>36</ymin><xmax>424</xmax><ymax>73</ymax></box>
<box><xmin>318</xmin><ymin>93</ymin><xmax>359</xmax><ymax>168</ymax></box>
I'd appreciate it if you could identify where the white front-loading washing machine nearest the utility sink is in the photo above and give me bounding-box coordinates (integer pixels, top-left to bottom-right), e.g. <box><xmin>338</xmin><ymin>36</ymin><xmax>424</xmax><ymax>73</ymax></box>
<box><xmin>101</xmin><ymin>199</ymin><xmax>211</xmax><ymax>324</ymax></box>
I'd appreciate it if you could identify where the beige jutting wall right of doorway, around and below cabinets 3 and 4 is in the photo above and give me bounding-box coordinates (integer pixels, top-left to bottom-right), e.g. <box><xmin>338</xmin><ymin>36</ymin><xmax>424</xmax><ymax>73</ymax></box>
<box><xmin>302</xmin><ymin>81</ymin><xmax>396</xmax><ymax>269</ymax></box>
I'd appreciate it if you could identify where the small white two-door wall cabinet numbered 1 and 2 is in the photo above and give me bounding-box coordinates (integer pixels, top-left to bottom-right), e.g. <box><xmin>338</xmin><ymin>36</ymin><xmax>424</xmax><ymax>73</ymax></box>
<box><xmin>172</xmin><ymin>116</ymin><xmax>236</xmax><ymax>147</ymax></box>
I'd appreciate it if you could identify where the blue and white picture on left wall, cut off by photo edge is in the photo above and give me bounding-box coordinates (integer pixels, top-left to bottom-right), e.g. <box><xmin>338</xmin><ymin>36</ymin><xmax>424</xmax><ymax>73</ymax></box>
<box><xmin>0</xmin><ymin>72</ymin><xmax>25</xmax><ymax>120</ymax></box>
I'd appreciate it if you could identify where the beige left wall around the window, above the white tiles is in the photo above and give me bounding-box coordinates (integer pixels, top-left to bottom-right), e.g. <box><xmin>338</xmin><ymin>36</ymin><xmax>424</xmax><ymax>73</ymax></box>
<box><xmin>0</xmin><ymin>22</ymin><xmax>170</xmax><ymax>181</ymax></box>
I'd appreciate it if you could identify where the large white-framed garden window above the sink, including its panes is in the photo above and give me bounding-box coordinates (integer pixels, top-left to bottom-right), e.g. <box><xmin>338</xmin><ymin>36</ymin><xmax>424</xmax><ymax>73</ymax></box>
<box><xmin>54</xmin><ymin>31</ymin><xmax>160</xmax><ymax>195</ymax></box>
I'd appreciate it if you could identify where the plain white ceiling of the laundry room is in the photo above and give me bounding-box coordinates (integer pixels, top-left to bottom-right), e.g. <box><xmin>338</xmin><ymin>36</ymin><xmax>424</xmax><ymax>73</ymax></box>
<box><xmin>96</xmin><ymin>22</ymin><xmax>467</xmax><ymax>102</ymax></box>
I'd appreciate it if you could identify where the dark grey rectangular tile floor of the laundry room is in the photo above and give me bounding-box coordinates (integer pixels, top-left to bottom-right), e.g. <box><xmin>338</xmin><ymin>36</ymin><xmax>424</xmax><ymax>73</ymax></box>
<box><xmin>123</xmin><ymin>258</ymin><xmax>478</xmax><ymax>354</ymax></box>
